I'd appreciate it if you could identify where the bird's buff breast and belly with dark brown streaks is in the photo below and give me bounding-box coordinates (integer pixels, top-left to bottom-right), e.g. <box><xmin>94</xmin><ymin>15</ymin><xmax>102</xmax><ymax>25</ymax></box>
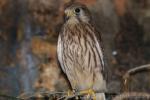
<box><xmin>57</xmin><ymin>26</ymin><xmax>103</xmax><ymax>90</ymax></box>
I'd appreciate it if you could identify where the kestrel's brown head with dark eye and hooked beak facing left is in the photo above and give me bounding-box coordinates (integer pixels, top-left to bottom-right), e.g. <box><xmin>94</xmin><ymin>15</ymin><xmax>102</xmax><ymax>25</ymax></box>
<box><xmin>65</xmin><ymin>3</ymin><xmax>91</xmax><ymax>24</ymax></box>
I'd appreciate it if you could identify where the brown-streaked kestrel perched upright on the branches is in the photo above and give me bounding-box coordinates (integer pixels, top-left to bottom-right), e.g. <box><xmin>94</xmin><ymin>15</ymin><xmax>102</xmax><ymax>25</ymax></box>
<box><xmin>57</xmin><ymin>2</ymin><xmax>106</xmax><ymax>100</ymax></box>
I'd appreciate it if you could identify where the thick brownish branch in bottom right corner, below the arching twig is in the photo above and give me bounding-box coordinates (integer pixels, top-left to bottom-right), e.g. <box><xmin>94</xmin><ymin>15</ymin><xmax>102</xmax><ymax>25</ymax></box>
<box><xmin>113</xmin><ymin>92</ymin><xmax>150</xmax><ymax>100</ymax></box>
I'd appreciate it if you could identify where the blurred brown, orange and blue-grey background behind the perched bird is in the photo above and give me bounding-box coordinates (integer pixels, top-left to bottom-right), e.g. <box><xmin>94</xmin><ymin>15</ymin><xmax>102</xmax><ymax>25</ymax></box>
<box><xmin>0</xmin><ymin>0</ymin><xmax>150</xmax><ymax>96</ymax></box>
